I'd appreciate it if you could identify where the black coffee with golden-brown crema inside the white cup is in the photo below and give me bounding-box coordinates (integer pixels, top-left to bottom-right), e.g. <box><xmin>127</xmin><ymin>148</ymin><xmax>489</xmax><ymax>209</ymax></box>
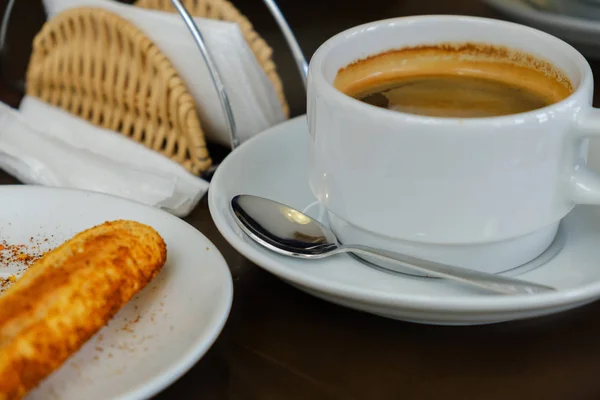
<box><xmin>334</xmin><ymin>44</ymin><xmax>573</xmax><ymax>118</ymax></box>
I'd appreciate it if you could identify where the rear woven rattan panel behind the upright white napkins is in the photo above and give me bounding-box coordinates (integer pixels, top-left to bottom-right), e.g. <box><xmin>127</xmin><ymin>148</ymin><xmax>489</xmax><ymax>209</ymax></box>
<box><xmin>134</xmin><ymin>0</ymin><xmax>289</xmax><ymax>118</ymax></box>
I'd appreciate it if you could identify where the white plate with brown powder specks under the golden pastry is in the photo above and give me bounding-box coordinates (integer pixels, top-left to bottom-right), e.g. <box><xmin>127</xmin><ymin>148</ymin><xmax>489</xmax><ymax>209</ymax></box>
<box><xmin>0</xmin><ymin>186</ymin><xmax>232</xmax><ymax>400</ymax></box>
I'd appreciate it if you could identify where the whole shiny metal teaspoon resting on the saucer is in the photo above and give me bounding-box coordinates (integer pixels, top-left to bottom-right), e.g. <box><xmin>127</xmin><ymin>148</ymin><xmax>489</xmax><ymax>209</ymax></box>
<box><xmin>230</xmin><ymin>195</ymin><xmax>556</xmax><ymax>295</ymax></box>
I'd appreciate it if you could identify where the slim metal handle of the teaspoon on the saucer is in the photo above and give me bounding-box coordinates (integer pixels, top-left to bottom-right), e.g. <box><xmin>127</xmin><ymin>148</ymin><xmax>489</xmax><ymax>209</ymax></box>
<box><xmin>334</xmin><ymin>245</ymin><xmax>556</xmax><ymax>294</ymax></box>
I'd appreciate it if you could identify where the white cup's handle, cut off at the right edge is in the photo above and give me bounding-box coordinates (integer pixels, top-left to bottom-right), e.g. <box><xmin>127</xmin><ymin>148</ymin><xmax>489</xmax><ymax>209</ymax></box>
<box><xmin>569</xmin><ymin>107</ymin><xmax>600</xmax><ymax>204</ymax></box>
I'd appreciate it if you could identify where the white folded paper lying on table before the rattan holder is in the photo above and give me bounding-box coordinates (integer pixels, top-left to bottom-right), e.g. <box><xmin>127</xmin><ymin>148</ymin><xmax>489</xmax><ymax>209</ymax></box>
<box><xmin>0</xmin><ymin>96</ymin><xmax>208</xmax><ymax>217</ymax></box>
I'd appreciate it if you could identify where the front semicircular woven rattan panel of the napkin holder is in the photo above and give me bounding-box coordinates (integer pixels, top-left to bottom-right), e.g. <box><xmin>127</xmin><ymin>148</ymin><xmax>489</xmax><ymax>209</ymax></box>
<box><xmin>26</xmin><ymin>8</ymin><xmax>211</xmax><ymax>174</ymax></box>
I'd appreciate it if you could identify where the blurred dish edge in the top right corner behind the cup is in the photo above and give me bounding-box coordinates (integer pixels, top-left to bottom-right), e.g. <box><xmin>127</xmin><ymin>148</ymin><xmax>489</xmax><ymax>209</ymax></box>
<box><xmin>485</xmin><ymin>0</ymin><xmax>600</xmax><ymax>58</ymax></box>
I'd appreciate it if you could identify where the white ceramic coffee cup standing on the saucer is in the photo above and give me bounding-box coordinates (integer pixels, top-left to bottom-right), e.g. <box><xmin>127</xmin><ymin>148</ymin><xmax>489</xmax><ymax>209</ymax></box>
<box><xmin>308</xmin><ymin>16</ymin><xmax>600</xmax><ymax>273</ymax></box>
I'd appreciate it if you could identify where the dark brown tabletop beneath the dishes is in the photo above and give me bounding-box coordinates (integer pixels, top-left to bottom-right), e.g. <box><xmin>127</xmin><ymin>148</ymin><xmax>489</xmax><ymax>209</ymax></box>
<box><xmin>0</xmin><ymin>0</ymin><xmax>600</xmax><ymax>400</ymax></box>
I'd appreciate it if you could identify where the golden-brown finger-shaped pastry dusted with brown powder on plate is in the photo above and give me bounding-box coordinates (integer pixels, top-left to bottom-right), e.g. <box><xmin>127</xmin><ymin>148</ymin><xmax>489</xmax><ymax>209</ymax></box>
<box><xmin>0</xmin><ymin>220</ymin><xmax>167</xmax><ymax>400</ymax></box>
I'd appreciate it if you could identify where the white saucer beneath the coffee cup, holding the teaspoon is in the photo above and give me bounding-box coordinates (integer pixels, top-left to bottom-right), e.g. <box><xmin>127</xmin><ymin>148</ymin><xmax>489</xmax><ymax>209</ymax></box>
<box><xmin>209</xmin><ymin>117</ymin><xmax>600</xmax><ymax>325</ymax></box>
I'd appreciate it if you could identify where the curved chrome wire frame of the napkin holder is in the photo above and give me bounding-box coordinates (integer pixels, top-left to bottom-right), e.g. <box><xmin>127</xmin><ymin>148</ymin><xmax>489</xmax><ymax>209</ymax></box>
<box><xmin>0</xmin><ymin>0</ymin><xmax>308</xmax><ymax>155</ymax></box>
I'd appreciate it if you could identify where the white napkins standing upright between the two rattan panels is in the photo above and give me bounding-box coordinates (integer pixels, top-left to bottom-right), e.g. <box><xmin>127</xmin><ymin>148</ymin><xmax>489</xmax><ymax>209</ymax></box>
<box><xmin>43</xmin><ymin>0</ymin><xmax>285</xmax><ymax>146</ymax></box>
